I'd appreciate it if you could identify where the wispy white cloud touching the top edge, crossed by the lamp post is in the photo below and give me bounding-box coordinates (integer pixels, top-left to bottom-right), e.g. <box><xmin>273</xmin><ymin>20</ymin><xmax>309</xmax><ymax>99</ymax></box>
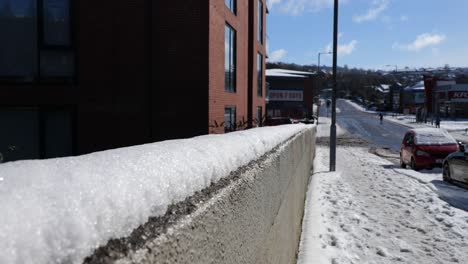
<box><xmin>268</xmin><ymin>0</ymin><xmax>348</xmax><ymax>16</ymax></box>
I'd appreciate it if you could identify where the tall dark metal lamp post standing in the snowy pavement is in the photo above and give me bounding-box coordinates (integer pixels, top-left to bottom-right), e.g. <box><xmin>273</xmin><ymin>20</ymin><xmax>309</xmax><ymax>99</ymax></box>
<box><xmin>330</xmin><ymin>0</ymin><xmax>338</xmax><ymax>171</ymax></box>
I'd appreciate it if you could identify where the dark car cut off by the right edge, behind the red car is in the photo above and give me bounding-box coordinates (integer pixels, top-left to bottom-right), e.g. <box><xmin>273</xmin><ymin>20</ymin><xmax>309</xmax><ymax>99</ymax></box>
<box><xmin>442</xmin><ymin>143</ymin><xmax>468</xmax><ymax>184</ymax></box>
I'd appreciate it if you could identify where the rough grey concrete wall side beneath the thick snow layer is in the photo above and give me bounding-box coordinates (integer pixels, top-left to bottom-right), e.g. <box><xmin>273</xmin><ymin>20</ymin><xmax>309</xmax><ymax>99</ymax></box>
<box><xmin>89</xmin><ymin>127</ymin><xmax>316</xmax><ymax>264</ymax></box>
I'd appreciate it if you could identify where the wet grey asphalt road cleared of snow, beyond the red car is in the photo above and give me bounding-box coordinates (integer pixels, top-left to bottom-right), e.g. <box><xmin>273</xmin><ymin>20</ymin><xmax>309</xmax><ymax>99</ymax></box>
<box><xmin>320</xmin><ymin>100</ymin><xmax>409</xmax><ymax>152</ymax></box>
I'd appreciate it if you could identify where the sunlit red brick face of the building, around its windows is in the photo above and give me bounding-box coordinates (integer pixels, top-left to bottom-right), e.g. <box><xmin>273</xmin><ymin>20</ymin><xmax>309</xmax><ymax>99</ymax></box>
<box><xmin>209</xmin><ymin>0</ymin><xmax>266</xmax><ymax>133</ymax></box>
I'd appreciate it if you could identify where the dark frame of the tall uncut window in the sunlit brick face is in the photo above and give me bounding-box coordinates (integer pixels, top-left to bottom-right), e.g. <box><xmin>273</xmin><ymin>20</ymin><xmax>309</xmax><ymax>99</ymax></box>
<box><xmin>224</xmin><ymin>23</ymin><xmax>237</xmax><ymax>93</ymax></box>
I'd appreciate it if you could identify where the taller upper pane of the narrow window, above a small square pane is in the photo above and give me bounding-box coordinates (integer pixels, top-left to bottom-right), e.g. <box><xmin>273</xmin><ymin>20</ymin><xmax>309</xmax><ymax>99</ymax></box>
<box><xmin>43</xmin><ymin>0</ymin><xmax>70</xmax><ymax>46</ymax></box>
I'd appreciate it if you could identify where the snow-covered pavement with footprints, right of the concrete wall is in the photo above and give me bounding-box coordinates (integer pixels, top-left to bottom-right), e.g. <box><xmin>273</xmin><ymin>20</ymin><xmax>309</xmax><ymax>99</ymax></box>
<box><xmin>298</xmin><ymin>119</ymin><xmax>468</xmax><ymax>264</ymax></box>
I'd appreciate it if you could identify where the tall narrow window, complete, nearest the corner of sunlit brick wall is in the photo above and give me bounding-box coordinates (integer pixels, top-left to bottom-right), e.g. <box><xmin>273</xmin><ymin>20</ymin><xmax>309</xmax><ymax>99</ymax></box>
<box><xmin>224</xmin><ymin>24</ymin><xmax>236</xmax><ymax>92</ymax></box>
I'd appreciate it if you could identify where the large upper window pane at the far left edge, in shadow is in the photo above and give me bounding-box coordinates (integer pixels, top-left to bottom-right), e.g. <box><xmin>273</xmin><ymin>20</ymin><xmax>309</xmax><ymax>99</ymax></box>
<box><xmin>0</xmin><ymin>0</ymin><xmax>37</xmax><ymax>82</ymax></box>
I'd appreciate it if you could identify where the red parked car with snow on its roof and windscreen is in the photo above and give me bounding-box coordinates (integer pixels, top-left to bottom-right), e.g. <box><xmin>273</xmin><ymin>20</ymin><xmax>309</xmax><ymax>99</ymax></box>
<box><xmin>400</xmin><ymin>128</ymin><xmax>458</xmax><ymax>170</ymax></box>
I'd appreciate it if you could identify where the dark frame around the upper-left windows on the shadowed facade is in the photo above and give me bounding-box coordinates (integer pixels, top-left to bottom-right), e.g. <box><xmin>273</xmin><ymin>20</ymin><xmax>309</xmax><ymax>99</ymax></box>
<box><xmin>0</xmin><ymin>0</ymin><xmax>78</xmax><ymax>86</ymax></box>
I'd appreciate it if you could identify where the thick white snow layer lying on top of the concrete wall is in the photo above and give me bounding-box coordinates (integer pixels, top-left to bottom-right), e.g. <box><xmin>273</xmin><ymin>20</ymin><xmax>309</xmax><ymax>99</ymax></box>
<box><xmin>0</xmin><ymin>124</ymin><xmax>311</xmax><ymax>264</ymax></box>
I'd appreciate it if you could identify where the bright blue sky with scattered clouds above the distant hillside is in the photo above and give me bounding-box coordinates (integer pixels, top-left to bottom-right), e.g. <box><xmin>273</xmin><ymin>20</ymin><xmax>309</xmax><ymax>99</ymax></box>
<box><xmin>267</xmin><ymin>0</ymin><xmax>468</xmax><ymax>70</ymax></box>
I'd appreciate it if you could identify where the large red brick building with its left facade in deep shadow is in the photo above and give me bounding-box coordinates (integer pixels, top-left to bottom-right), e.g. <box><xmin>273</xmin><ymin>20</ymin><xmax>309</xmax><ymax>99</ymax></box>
<box><xmin>0</xmin><ymin>0</ymin><xmax>266</xmax><ymax>161</ymax></box>
